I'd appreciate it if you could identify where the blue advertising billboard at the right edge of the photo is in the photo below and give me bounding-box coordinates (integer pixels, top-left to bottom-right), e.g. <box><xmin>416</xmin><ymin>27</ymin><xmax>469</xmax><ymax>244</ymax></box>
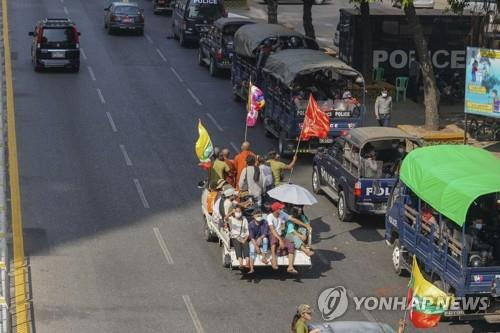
<box><xmin>465</xmin><ymin>47</ymin><xmax>500</xmax><ymax>118</ymax></box>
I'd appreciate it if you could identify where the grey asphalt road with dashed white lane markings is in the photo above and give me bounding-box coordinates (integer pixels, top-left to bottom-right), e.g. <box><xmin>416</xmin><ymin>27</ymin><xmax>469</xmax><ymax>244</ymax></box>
<box><xmin>9</xmin><ymin>0</ymin><xmax>494</xmax><ymax>333</ymax></box>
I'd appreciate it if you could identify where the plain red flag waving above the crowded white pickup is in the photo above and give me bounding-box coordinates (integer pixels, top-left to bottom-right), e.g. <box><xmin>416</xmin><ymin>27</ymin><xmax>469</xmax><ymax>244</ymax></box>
<box><xmin>300</xmin><ymin>94</ymin><xmax>330</xmax><ymax>141</ymax></box>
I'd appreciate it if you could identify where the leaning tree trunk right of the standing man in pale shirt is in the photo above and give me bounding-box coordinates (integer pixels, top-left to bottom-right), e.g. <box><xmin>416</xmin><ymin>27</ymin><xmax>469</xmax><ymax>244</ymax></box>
<box><xmin>401</xmin><ymin>0</ymin><xmax>439</xmax><ymax>131</ymax></box>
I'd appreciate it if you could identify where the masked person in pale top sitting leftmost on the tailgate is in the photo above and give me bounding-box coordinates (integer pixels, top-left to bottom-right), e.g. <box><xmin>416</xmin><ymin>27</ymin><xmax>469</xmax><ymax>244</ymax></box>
<box><xmin>224</xmin><ymin>207</ymin><xmax>250</xmax><ymax>270</ymax></box>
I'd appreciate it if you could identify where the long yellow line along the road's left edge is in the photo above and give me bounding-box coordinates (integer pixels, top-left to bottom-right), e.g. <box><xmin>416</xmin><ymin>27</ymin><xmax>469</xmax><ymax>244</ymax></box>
<box><xmin>2</xmin><ymin>0</ymin><xmax>30</xmax><ymax>332</ymax></box>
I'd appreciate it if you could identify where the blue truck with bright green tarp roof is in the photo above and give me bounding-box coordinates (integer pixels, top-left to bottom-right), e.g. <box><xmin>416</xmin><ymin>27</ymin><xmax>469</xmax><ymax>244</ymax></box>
<box><xmin>385</xmin><ymin>145</ymin><xmax>500</xmax><ymax>323</ymax></box>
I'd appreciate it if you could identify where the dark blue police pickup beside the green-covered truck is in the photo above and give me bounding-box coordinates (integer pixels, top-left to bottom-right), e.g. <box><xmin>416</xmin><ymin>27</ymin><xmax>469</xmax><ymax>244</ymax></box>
<box><xmin>312</xmin><ymin>127</ymin><xmax>420</xmax><ymax>221</ymax></box>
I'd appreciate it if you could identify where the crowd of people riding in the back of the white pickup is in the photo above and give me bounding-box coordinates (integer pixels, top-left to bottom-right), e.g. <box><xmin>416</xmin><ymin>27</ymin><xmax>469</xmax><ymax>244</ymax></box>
<box><xmin>202</xmin><ymin>141</ymin><xmax>314</xmax><ymax>274</ymax></box>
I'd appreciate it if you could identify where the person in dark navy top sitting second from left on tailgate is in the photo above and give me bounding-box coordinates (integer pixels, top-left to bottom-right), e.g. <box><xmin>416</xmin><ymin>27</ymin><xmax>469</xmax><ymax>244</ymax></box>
<box><xmin>248</xmin><ymin>210</ymin><xmax>269</xmax><ymax>274</ymax></box>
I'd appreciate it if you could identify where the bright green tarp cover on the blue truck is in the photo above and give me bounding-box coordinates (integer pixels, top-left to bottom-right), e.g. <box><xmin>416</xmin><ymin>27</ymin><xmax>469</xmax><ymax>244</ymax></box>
<box><xmin>400</xmin><ymin>145</ymin><xmax>500</xmax><ymax>226</ymax></box>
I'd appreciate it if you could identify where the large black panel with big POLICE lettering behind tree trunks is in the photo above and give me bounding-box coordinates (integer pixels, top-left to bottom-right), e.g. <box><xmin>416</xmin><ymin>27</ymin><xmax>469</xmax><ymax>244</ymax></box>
<box><xmin>334</xmin><ymin>4</ymin><xmax>472</xmax><ymax>86</ymax></box>
